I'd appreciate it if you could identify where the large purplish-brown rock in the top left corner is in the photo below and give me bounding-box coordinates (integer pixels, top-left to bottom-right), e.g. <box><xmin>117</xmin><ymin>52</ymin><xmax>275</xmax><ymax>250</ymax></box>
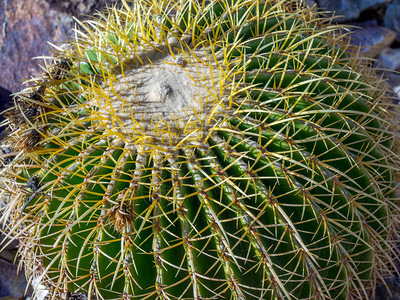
<box><xmin>0</xmin><ymin>0</ymin><xmax>73</xmax><ymax>92</ymax></box>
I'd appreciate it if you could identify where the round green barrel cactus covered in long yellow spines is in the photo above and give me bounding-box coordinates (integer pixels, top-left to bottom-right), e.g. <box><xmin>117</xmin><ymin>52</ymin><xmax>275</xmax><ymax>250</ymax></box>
<box><xmin>2</xmin><ymin>0</ymin><xmax>399</xmax><ymax>299</ymax></box>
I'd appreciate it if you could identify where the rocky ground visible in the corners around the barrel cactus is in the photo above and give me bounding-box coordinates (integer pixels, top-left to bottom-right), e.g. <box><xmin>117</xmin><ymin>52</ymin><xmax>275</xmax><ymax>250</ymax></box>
<box><xmin>0</xmin><ymin>0</ymin><xmax>400</xmax><ymax>300</ymax></box>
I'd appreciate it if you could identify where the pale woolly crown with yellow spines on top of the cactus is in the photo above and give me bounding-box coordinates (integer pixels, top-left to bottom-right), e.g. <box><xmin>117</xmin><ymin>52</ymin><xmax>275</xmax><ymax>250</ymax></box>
<box><xmin>94</xmin><ymin>41</ymin><xmax>234</xmax><ymax>151</ymax></box>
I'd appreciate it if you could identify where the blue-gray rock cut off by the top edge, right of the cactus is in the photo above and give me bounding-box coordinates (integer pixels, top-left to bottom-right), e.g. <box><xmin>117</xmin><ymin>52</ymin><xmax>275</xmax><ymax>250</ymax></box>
<box><xmin>317</xmin><ymin>0</ymin><xmax>390</xmax><ymax>21</ymax></box>
